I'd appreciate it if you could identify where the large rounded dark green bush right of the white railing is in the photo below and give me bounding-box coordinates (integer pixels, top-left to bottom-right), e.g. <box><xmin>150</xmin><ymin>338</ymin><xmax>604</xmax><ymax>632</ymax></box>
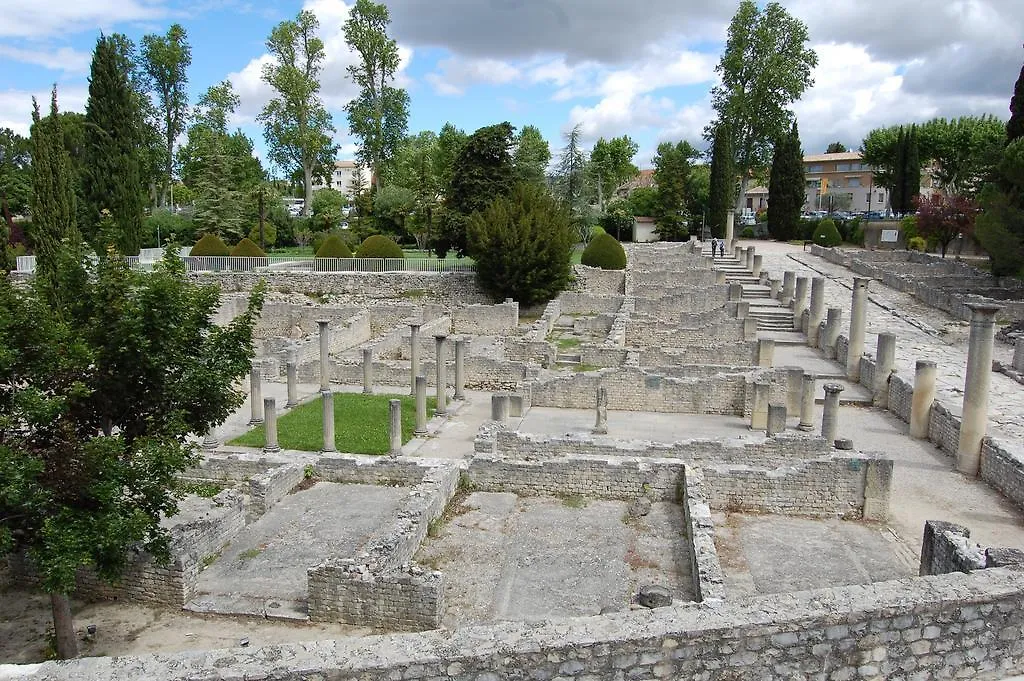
<box><xmin>467</xmin><ymin>183</ymin><xmax>574</xmax><ymax>305</ymax></box>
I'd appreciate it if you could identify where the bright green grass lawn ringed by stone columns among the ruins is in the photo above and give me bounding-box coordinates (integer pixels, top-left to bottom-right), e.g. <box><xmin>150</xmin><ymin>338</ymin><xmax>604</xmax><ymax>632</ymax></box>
<box><xmin>228</xmin><ymin>392</ymin><xmax>437</xmax><ymax>454</ymax></box>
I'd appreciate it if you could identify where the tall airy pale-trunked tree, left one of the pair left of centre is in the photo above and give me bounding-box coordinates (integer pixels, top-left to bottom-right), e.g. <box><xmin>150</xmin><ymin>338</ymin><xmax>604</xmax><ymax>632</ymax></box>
<box><xmin>258</xmin><ymin>9</ymin><xmax>338</xmax><ymax>216</ymax></box>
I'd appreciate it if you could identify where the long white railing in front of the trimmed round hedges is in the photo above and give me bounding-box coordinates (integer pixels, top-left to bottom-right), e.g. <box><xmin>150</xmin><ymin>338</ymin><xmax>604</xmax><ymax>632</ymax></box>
<box><xmin>16</xmin><ymin>249</ymin><xmax>476</xmax><ymax>273</ymax></box>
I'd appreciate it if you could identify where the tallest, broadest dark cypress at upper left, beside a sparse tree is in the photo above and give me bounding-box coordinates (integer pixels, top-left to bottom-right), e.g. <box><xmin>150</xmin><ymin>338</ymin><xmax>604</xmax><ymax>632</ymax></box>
<box><xmin>82</xmin><ymin>36</ymin><xmax>142</xmax><ymax>255</ymax></box>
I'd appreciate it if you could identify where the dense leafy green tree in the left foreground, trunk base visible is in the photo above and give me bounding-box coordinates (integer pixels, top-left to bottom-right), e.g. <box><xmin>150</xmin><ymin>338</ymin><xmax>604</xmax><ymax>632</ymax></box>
<box><xmin>0</xmin><ymin>246</ymin><xmax>262</xmax><ymax>658</ymax></box>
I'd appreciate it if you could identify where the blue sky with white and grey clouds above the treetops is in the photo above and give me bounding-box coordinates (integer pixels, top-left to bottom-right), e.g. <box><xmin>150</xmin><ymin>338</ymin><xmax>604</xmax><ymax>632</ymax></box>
<box><xmin>0</xmin><ymin>0</ymin><xmax>1024</xmax><ymax>173</ymax></box>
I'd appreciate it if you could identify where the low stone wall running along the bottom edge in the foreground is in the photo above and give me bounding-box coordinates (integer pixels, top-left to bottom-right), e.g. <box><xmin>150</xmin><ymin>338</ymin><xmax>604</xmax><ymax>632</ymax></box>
<box><xmin>13</xmin><ymin>568</ymin><xmax>1024</xmax><ymax>681</ymax></box>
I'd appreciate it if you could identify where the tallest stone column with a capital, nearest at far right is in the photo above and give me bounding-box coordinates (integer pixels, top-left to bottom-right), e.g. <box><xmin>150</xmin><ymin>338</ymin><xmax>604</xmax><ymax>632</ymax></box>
<box><xmin>956</xmin><ymin>303</ymin><xmax>1001</xmax><ymax>476</ymax></box>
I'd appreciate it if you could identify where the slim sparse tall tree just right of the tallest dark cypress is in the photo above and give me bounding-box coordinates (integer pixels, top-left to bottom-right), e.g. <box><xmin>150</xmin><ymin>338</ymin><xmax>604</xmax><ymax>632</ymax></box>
<box><xmin>139</xmin><ymin>24</ymin><xmax>191</xmax><ymax>205</ymax></box>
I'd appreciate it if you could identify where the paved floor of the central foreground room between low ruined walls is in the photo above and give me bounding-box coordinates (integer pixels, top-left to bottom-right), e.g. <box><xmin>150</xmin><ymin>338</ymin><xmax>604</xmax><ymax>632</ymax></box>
<box><xmin>416</xmin><ymin>493</ymin><xmax>693</xmax><ymax>627</ymax></box>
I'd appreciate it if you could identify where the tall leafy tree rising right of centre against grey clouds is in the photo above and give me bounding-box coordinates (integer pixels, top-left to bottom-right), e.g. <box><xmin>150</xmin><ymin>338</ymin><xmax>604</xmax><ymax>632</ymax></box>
<box><xmin>705</xmin><ymin>0</ymin><xmax>818</xmax><ymax>210</ymax></box>
